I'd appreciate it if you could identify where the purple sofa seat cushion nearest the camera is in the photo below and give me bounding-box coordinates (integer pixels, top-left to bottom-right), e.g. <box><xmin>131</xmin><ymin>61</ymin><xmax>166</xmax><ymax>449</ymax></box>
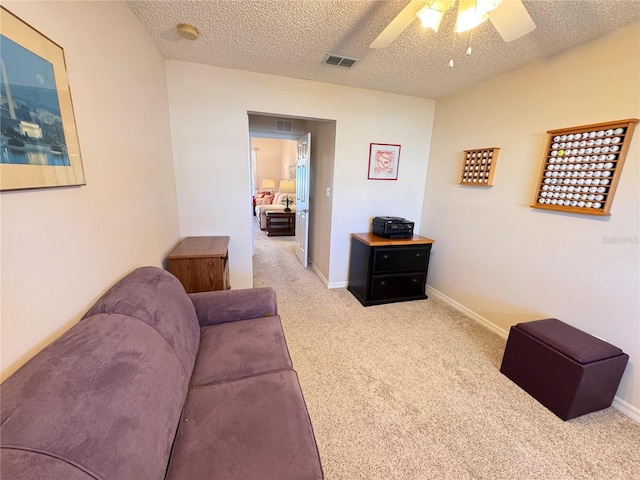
<box><xmin>167</xmin><ymin>370</ymin><xmax>322</xmax><ymax>480</ymax></box>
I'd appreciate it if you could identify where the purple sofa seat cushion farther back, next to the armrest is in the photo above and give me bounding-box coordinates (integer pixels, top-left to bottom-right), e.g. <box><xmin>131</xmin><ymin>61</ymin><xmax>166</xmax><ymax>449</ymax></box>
<box><xmin>191</xmin><ymin>316</ymin><xmax>292</xmax><ymax>385</ymax></box>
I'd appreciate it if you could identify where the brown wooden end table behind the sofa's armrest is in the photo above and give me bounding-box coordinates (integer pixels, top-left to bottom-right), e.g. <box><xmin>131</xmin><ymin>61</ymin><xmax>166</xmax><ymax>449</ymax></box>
<box><xmin>167</xmin><ymin>237</ymin><xmax>231</xmax><ymax>293</ymax></box>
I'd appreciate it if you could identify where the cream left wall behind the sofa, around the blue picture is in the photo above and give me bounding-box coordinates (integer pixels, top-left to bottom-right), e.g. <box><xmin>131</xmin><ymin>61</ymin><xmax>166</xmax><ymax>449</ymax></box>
<box><xmin>0</xmin><ymin>2</ymin><xmax>179</xmax><ymax>379</ymax></box>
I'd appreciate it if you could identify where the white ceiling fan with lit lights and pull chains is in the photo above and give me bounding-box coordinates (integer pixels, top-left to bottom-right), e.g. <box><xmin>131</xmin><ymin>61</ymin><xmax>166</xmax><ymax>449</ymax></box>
<box><xmin>369</xmin><ymin>0</ymin><xmax>536</xmax><ymax>48</ymax></box>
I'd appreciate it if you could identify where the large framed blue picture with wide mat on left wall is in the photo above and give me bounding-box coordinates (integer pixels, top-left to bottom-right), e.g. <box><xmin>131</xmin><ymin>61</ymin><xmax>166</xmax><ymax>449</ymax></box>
<box><xmin>0</xmin><ymin>7</ymin><xmax>85</xmax><ymax>190</ymax></box>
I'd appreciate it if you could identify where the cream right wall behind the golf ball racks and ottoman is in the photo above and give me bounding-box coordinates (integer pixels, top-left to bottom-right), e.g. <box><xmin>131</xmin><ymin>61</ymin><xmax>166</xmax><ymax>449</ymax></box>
<box><xmin>421</xmin><ymin>23</ymin><xmax>640</xmax><ymax>409</ymax></box>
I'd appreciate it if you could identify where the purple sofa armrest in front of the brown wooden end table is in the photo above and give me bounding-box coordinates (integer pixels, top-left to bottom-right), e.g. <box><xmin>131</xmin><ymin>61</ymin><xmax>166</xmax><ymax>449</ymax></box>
<box><xmin>189</xmin><ymin>287</ymin><xmax>278</xmax><ymax>326</ymax></box>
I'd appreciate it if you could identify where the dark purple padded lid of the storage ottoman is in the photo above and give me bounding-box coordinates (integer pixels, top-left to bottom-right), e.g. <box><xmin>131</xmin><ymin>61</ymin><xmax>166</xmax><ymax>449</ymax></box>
<box><xmin>516</xmin><ymin>318</ymin><xmax>623</xmax><ymax>365</ymax></box>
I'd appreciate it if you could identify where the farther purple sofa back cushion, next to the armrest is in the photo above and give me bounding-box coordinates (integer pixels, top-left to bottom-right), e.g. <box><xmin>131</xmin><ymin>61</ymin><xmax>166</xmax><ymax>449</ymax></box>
<box><xmin>83</xmin><ymin>267</ymin><xmax>200</xmax><ymax>377</ymax></box>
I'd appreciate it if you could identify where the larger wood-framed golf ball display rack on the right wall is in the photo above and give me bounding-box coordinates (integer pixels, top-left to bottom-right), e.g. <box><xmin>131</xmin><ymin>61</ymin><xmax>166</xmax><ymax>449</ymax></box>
<box><xmin>531</xmin><ymin>118</ymin><xmax>638</xmax><ymax>215</ymax></box>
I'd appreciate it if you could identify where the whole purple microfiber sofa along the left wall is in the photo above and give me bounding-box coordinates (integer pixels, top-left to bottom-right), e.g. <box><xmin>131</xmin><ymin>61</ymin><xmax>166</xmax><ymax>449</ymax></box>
<box><xmin>0</xmin><ymin>267</ymin><xmax>323</xmax><ymax>480</ymax></box>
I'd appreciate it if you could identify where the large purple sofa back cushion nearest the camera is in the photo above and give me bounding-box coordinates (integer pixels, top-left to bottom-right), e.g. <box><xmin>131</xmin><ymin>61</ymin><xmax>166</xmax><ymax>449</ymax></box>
<box><xmin>0</xmin><ymin>314</ymin><xmax>189</xmax><ymax>479</ymax></box>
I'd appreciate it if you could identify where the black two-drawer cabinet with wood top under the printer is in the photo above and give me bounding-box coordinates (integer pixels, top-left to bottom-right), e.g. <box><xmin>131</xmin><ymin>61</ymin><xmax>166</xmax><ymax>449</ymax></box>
<box><xmin>347</xmin><ymin>233</ymin><xmax>434</xmax><ymax>307</ymax></box>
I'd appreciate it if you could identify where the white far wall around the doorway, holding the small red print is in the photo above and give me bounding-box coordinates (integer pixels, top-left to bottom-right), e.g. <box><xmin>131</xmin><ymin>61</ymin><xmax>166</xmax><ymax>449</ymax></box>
<box><xmin>167</xmin><ymin>60</ymin><xmax>434</xmax><ymax>288</ymax></box>
